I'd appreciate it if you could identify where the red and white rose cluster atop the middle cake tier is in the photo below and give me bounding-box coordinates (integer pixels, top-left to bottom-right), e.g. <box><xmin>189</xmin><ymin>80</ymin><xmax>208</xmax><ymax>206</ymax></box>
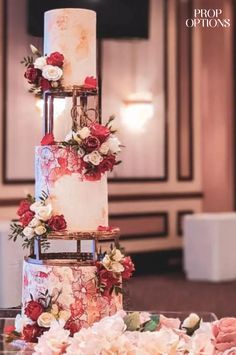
<box><xmin>41</xmin><ymin>117</ymin><xmax>121</xmax><ymax>181</ymax></box>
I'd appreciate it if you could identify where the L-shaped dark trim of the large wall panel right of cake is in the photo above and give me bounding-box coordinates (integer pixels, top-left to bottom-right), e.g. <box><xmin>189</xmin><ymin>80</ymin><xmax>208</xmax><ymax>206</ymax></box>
<box><xmin>108</xmin><ymin>0</ymin><xmax>169</xmax><ymax>184</ymax></box>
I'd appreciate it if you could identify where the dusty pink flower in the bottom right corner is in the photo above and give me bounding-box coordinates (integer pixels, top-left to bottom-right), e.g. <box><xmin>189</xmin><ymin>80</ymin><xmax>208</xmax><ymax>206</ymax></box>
<box><xmin>212</xmin><ymin>317</ymin><xmax>236</xmax><ymax>351</ymax></box>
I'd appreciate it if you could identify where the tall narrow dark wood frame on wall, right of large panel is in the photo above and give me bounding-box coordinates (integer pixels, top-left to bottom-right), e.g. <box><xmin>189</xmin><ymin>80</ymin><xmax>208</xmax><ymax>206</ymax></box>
<box><xmin>176</xmin><ymin>0</ymin><xmax>194</xmax><ymax>181</ymax></box>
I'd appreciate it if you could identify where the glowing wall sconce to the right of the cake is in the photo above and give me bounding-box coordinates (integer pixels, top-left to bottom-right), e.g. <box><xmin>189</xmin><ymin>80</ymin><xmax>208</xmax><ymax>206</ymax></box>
<box><xmin>121</xmin><ymin>93</ymin><xmax>154</xmax><ymax>133</ymax></box>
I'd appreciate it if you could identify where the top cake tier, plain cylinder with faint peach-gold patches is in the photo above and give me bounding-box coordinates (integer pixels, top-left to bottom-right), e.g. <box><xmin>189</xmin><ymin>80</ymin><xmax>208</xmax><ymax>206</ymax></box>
<box><xmin>44</xmin><ymin>9</ymin><xmax>96</xmax><ymax>87</ymax></box>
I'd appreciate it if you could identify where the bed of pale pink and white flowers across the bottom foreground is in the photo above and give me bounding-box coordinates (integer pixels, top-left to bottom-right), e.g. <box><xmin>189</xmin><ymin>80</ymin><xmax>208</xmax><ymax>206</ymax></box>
<box><xmin>6</xmin><ymin>311</ymin><xmax>236</xmax><ymax>355</ymax></box>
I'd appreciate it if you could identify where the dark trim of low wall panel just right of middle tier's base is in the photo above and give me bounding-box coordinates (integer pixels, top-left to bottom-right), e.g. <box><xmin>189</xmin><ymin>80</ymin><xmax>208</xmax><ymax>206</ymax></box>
<box><xmin>109</xmin><ymin>211</ymin><xmax>169</xmax><ymax>240</ymax></box>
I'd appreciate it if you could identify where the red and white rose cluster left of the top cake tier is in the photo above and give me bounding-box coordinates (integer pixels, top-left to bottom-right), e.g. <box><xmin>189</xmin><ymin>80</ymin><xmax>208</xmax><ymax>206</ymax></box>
<box><xmin>22</xmin><ymin>45</ymin><xmax>64</xmax><ymax>95</ymax></box>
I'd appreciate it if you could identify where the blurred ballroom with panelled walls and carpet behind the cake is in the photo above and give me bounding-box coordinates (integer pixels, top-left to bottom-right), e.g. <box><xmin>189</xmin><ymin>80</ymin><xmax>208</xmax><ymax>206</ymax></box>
<box><xmin>0</xmin><ymin>0</ymin><xmax>236</xmax><ymax>316</ymax></box>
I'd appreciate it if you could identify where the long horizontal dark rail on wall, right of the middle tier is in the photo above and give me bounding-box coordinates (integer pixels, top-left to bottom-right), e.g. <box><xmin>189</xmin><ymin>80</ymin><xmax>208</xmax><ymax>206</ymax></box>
<box><xmin>108</xmin><ymin>192</ymin><xmax>204</xmax><ymax>202</ymax></box>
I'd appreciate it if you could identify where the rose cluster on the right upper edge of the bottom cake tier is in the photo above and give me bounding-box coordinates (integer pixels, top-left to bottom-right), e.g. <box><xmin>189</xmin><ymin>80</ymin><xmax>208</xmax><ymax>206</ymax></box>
<box><xmin>96</xmin><ymin>248</ymin><xmax>135</xmax><ymax>297</ymax></box>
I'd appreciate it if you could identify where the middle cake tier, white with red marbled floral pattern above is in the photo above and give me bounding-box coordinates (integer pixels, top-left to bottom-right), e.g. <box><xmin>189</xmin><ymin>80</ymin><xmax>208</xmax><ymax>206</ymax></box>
<box><xmin>35</xmin><ymin>145</ymin><xmax>108</xmax><ymax>231</ymax></box>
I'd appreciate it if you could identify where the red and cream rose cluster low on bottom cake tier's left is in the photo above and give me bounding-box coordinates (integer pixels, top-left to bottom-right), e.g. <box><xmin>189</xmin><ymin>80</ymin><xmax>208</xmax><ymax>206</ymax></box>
<box><xmin>9</xmin><ymin>291</ymin><xmax>71</xmax><ymax>343</ymax></box>
